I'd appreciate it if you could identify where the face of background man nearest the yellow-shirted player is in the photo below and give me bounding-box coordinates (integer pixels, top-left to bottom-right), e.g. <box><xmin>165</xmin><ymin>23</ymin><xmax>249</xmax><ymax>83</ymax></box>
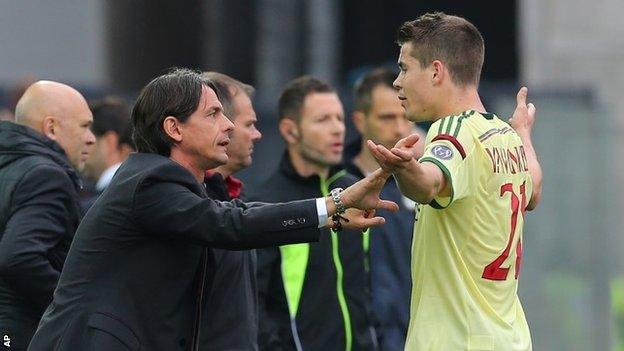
<box><xmin>361</xmin><ymin>85</ymin><xmax>413</xmax><ymax>149</ymax></box>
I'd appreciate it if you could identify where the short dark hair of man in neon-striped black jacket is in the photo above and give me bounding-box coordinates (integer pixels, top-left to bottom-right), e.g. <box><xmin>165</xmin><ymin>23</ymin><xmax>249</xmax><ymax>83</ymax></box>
<box><xmin>277</xmin><ymin>76</ymin><xmax>336</xmax><ymax>123</ymax></box>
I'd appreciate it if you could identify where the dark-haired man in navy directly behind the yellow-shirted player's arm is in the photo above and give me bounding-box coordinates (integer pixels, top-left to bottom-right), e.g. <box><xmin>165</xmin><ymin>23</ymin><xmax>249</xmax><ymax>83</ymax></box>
<box><xmin>346</xmin><ymin>68</ymin><xmax>423</xmax><ymax>350</ymax></box>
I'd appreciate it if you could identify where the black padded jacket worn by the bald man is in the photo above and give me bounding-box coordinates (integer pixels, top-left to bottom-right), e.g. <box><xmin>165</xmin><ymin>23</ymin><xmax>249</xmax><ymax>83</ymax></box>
<box><xmin>0</xmin><ymin>122</ymin><xmax>81</xmax><ymax>350</ymax></box>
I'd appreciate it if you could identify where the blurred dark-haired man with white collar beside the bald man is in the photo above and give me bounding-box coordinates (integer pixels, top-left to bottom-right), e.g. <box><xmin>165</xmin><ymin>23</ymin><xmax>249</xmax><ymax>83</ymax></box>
<box><xmin>83</xmin><ymin>96</ymin><xmax>134</xmax><ymax>210</ymax></box>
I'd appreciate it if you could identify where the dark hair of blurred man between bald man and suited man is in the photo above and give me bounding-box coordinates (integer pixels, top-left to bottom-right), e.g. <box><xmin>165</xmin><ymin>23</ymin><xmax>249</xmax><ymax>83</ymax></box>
<box><xmin>89</xmin><ymin>96</ymin><xmax>134</xmax><ymax>148</ymax></box>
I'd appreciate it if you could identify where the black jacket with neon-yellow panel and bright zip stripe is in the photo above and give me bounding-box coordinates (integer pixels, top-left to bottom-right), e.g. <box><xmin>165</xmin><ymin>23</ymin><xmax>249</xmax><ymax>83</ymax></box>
<box><xmin>252</xmin><ymin>153</ymin><xmax>376</xmax><ymax>351</ymax></box>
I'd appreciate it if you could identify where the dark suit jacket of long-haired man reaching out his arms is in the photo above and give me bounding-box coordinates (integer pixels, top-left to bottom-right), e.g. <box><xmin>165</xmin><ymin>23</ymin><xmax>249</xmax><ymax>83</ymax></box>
<box><xmin>29</xmin><ymin>153</ymin><xmax>319</xmax><ymax>351</ymax></box>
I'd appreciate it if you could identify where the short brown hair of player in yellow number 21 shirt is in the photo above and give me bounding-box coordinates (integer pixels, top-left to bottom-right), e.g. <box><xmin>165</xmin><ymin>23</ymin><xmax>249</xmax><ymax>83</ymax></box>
<box><xmin>397</xmin><ymin>12</ymin><xmax>485</xmax><ymax>86</ymax></box>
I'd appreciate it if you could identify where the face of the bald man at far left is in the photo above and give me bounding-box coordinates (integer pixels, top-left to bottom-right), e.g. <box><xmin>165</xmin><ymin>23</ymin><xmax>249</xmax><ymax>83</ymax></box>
<box><xmin>54</xmin><ymin>101</ymin><xmax>95</xmax><ymax>171</ymax></box>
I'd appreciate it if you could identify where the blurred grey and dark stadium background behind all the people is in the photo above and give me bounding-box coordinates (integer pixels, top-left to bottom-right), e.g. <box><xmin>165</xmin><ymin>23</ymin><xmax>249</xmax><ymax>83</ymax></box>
<box><xmin>0</xmin><ymin>0</ymin><xmax>624</xmax><ymax>351</ymax></box>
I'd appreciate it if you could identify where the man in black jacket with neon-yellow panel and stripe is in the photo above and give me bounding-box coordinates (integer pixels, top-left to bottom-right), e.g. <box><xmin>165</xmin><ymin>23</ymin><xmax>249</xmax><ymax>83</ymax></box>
<box><xmin>253</xmin><ymin>76</ymin><xmax>376</xmax><ymax>350</ymax></box>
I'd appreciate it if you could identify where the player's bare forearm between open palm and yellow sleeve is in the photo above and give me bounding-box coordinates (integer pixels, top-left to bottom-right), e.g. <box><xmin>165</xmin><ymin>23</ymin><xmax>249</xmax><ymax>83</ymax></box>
<box><xmin>394</xmin><ymin>160</ymin><xmax>444</xmax><ymax>204</ymax></box>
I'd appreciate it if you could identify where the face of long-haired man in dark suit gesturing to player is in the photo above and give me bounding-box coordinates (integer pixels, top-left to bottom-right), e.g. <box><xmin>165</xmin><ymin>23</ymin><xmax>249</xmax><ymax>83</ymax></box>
<box><xmin>177</xmin><ymin>86</ymin><xmax>234</xmax><ymax>170</ymax></box>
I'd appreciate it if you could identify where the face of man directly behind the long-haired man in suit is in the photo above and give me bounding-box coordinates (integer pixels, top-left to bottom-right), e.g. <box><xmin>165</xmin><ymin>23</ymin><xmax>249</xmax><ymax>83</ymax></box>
<box><xmin>227</xmin><ymin>91</ymin><xmax>262</xmax><ymax>170</ymax></box>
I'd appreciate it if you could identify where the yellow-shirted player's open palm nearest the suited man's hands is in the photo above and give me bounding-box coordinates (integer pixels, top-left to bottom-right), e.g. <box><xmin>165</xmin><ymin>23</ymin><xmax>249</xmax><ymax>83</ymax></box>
<box><xmin>367</xmin><ymin>134</ymin><xmax>420</xmax><ymax>173</ymax></box>
